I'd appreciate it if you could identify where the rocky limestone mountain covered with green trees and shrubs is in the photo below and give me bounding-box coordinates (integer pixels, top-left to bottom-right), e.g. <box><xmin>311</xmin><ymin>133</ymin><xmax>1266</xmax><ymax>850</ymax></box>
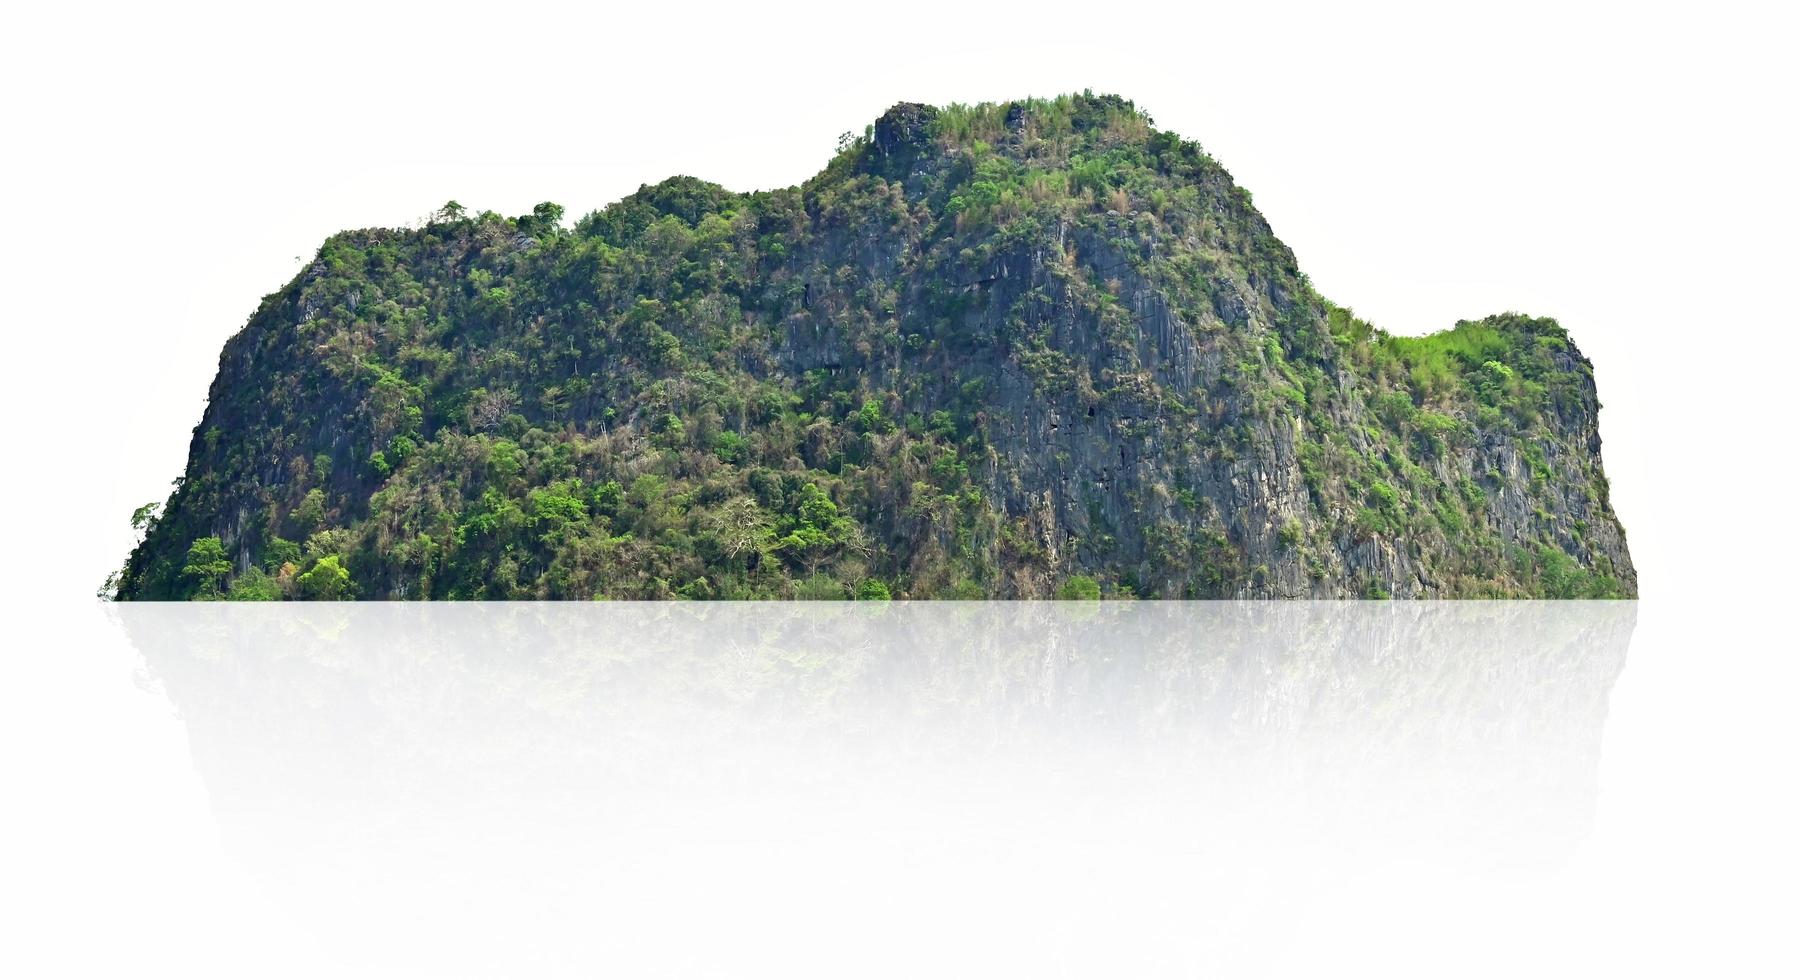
<box><xmin>115</xmin><ymin>94</ymin><xmax>1636</xmax><ymax>598</ymax></box>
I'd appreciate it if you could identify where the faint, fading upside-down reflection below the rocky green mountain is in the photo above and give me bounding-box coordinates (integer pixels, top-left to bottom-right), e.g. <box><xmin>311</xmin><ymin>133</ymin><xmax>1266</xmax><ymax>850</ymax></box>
<box><xmin>117</xmin><ymin>602</ymin><xmax>1636</xmax><ymax>966</ymax></box>
